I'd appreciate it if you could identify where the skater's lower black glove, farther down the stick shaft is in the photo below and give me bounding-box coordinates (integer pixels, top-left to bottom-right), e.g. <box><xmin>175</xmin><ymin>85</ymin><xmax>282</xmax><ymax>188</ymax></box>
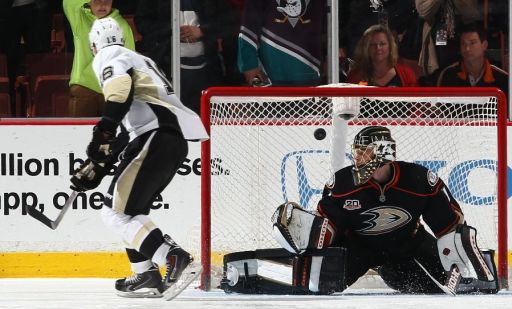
<box><xmin>71</xmin><ymin>159</ymin><xmax>112</xmax><ymax>192</ymax></box>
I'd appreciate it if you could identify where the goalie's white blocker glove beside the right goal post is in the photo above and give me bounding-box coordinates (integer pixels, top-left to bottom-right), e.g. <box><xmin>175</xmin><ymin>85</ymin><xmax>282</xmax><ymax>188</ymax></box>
<box><xmin>437</xmin><ymin>225</ymin><xmax>495</xmax><ymax>281</ymax></box>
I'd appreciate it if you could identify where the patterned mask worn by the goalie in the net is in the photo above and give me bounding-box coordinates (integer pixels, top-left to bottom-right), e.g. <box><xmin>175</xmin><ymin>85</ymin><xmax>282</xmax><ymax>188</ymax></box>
<box><xmin>352</xmin><ymin>126</ymin><xmax>396</xmax><ymax>185</ymax></box>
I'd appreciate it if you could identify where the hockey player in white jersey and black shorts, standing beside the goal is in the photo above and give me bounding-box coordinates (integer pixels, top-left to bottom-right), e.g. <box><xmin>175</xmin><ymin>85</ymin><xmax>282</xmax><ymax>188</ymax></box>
<box><xmin>71</xmin><ymin>17</ymin><xmax>208</xmax><ymax>300</ymax></box>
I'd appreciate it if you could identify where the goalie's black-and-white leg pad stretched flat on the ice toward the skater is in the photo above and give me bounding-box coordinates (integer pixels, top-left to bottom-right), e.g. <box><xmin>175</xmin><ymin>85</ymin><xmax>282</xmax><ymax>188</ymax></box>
<box><xmin>220</xmin><ymin>248</ymin><xmax>346</xmax><ymax>295</ymax></box>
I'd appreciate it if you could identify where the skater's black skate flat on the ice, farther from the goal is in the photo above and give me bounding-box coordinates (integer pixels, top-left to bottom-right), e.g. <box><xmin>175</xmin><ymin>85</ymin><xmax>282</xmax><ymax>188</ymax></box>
<box><xmin>116</xmin><ymin>266</ymin><xmax>165</xmax><ymax>298</ymax></box>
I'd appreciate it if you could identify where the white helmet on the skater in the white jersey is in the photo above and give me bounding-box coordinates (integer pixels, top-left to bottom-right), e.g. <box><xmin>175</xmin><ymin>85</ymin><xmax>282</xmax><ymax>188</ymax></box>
<box><xmin>89</xmin><ymin>17</ymin><xmax>124</xmax><ymax>53</ymax></box>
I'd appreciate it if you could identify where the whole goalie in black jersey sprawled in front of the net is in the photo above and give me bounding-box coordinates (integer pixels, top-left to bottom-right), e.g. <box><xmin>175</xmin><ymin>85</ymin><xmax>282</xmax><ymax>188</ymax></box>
<box><xmin>222</xmin><ymin>126</ymin><xmax>499</xmax><ymax>295</ymax></box>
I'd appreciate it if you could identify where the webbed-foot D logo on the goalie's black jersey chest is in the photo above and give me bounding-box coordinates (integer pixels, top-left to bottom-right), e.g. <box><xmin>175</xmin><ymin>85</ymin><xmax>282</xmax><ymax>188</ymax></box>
<box><xmin>356</xmin><ymin>206</ymin><xmax>412</xmax><ymax>235</ymax></box>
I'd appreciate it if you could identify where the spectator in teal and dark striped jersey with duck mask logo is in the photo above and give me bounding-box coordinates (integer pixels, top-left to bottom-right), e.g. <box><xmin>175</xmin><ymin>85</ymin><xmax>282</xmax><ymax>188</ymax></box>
<box><xmin>238</xmin><ymin>0</ymin><xmax>327</xmax><ymax>86</ymax></box>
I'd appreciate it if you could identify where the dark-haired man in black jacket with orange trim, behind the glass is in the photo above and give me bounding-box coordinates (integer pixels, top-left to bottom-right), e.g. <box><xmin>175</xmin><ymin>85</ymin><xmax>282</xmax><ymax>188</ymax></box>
<box><xmin>437</xmin><ymin>24</ymin><xmax>508</xmax><ymax>94</ymax></box>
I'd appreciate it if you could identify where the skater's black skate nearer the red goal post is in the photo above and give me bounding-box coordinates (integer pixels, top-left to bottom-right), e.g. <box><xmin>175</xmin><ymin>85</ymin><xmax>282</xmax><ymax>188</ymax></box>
<box><xmin>163</xmin><ymin>235</ymin><xmax>202</xmax><ymax>300</ymax></box>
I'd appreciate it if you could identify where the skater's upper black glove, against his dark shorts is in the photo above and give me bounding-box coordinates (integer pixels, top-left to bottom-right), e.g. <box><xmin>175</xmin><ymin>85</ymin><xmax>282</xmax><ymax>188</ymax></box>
<box><xmin>86</xmin><ymin>122</ymin><xmax>116</xmax><ymax>163</ymax></box>
